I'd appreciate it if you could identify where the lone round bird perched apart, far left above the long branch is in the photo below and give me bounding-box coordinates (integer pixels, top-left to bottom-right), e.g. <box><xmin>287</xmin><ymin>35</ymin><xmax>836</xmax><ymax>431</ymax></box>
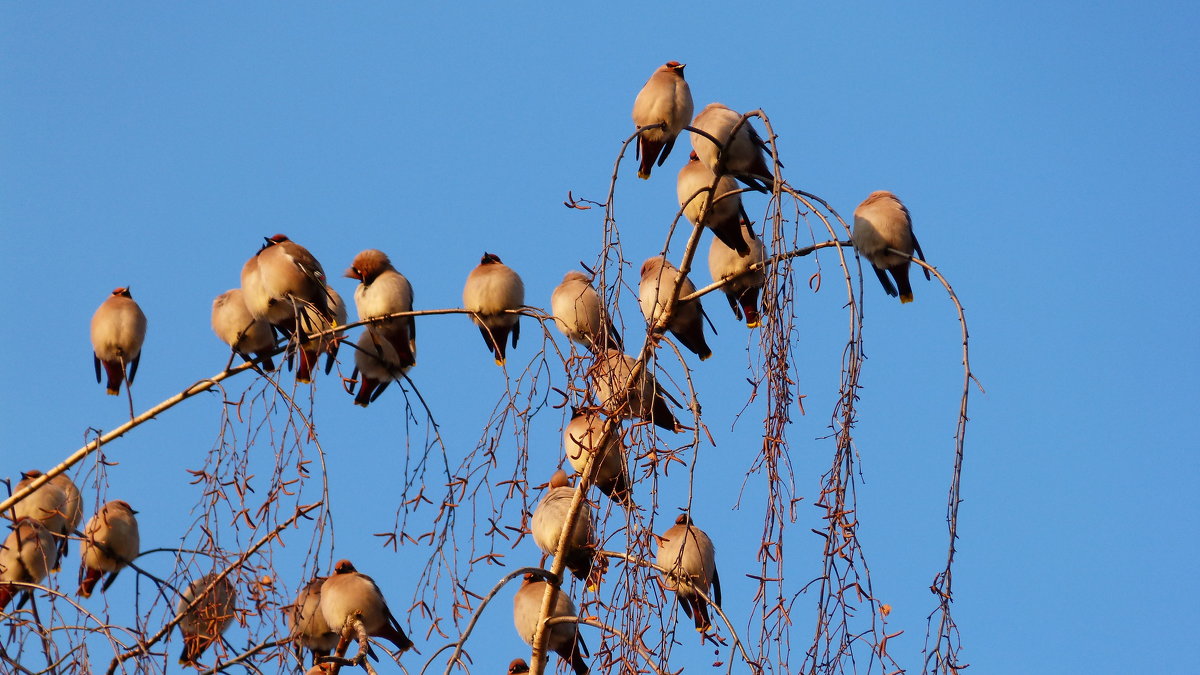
<box><xmin>91</xmin><ymin>286</ymin><xmax>146</xmax><ymax>396</ymax></box>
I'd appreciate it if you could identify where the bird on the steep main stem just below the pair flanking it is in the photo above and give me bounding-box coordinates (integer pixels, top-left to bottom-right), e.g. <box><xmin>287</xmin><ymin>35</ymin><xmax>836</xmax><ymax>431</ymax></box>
<box><xmin>588</xmin><ymin>350</ymin><xmax>683</xmax><ymax>431</ymax></box>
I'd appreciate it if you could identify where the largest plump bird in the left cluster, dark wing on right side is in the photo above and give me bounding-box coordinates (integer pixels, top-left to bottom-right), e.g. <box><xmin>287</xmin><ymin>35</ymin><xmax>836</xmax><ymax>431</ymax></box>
<box><xmin>241</xmin><ymin>234</ymin><xmax>334</xmax><ymax>383</ymax></box>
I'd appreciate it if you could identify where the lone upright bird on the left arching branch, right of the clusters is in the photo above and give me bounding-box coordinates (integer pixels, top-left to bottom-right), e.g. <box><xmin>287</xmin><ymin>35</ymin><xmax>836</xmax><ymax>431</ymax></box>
<box><xmin>462</xmin><ymin>252</ymin><xmax>524</xmax><ymax>365</ymax></box>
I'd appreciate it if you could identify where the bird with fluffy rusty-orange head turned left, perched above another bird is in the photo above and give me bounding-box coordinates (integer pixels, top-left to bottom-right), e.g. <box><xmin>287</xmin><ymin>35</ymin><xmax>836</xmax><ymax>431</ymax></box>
<box><xmin>346</xmin><ymin>249</ymin><xmax>416</xmax><ymax>368</ymax></box>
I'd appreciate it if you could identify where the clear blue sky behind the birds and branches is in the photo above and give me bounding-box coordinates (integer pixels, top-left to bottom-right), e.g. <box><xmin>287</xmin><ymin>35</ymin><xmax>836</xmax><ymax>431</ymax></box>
<box><xmin>0</xmin><ymin>2</ymin><xmax>1200</xmax><ymax>674</ymax></box>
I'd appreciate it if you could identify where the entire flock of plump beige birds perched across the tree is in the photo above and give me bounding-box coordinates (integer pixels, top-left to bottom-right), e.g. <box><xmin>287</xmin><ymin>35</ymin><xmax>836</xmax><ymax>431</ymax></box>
<box><xmin>0</xmin><ymin>61</ymin><xmax>929</xmax><ymax>675</ymax></box>
